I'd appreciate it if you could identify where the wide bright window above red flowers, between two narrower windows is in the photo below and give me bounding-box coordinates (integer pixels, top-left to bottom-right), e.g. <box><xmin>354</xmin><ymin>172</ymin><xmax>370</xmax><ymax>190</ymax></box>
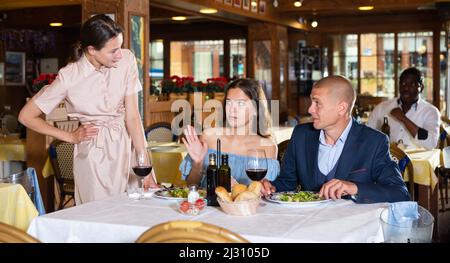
<box><xmin>170</xmin><ymin>40</ymin><xmax>224</xmax><ymax>82</ymax></box>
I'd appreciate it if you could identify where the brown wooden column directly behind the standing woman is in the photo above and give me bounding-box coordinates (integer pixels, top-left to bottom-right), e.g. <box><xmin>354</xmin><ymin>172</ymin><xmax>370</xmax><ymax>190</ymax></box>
<box><xmin>82</xmin><ymin>0</ymin><xmax>150</xmax><ymax>127</ymax></box>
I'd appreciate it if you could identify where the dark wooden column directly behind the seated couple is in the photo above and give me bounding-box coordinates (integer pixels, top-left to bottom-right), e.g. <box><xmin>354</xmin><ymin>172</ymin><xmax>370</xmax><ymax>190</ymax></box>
<box><xmin>248</xmin><ymin>23</ymin><xmax>288</xmax><ymax>122</ymax></box>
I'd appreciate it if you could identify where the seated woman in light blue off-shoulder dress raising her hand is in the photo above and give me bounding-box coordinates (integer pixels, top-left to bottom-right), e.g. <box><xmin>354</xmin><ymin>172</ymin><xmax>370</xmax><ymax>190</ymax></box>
<box><xmin>180</xmin><ymin>79</ymin><xmax>280</xmax><ymax>187</ymax></box>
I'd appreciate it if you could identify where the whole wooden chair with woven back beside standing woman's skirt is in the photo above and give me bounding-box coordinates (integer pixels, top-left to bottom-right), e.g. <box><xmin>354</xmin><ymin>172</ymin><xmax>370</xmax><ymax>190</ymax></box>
<box><xmin>48</xmin><ymin>140</ymin><xmax>75</xmax><ymax>209</ymax></box>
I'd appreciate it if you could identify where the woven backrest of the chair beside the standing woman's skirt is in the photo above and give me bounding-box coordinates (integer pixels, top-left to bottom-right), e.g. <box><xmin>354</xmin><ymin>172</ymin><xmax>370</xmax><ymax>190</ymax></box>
<box><xmin>48</xmin><ymin>140</ymin><xmax>74</xmax><ymax>184</ymax></box>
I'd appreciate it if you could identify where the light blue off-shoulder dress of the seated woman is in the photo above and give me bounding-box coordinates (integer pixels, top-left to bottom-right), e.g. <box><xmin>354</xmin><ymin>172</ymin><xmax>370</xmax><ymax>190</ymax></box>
<box><xmin>179</xmin><ymin>149</ymin><xmax>280</xmax><ymax>187</ymax></box>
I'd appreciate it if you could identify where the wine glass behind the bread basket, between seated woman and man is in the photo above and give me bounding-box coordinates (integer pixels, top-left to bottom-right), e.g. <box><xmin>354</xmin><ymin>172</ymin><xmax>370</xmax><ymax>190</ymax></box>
<box><xmin>245</xmin><ymin>149</ymin><xmax>267</xmax><ymax>181</ymax></box>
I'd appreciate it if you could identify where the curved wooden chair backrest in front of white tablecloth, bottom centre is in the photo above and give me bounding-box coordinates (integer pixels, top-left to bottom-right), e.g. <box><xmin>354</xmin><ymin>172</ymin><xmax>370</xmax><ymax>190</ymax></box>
<box><xmin>136</xmin><ymin>221</ymin><xmax>249</xmax><ymax>243</ymax></box>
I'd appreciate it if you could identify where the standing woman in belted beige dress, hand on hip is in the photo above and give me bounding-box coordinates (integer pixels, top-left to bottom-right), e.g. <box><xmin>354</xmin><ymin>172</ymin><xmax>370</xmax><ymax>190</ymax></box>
<box><xmin>19</xmin><ymin>15</ymin><xmax>157</xmax><ymax>205</ymax></box>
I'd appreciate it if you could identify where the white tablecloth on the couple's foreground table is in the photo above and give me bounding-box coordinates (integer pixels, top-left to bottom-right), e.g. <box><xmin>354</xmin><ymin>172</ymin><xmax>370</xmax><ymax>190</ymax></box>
<box><xmin>28</xmin><ymin>194</ymin><xmax>387</xmax><ymax>243</ymax></box>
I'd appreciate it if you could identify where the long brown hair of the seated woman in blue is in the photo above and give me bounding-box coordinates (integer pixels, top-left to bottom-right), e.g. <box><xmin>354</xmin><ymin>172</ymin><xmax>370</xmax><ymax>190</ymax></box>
<box><xmin>223</xmin><ymin>78</ymin><xmax>272</xmax><ymax>138</ymax></box>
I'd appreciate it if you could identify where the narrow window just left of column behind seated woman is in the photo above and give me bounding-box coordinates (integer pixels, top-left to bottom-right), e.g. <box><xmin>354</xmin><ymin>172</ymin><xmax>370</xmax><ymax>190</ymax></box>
<box><xmin>230</xmin><ymin>39</ymin><xmax>247</xmax><ymax>78</ymax></box>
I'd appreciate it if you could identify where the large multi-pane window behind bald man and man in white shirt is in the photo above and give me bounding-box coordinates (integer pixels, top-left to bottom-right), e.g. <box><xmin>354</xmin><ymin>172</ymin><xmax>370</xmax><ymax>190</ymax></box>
<box><xmin>331</xmin><ymin>32</ymin><xmax>440</xmax><ymax>105</ymax></box>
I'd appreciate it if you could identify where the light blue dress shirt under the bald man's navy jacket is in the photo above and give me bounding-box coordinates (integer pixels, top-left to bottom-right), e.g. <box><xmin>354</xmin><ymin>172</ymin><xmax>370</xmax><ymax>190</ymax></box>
<box><xmin>317</xmin><ymin>119</ymin><xmax>352</xmax><ymax>176</ymax></box>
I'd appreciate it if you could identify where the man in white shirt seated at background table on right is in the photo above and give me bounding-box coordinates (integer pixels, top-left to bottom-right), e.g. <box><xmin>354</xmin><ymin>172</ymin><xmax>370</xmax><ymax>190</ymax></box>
<box><xmin>367</xmin><ymin>68</ymin><xmax>441</xmax><ymax>149</ymax></box>
